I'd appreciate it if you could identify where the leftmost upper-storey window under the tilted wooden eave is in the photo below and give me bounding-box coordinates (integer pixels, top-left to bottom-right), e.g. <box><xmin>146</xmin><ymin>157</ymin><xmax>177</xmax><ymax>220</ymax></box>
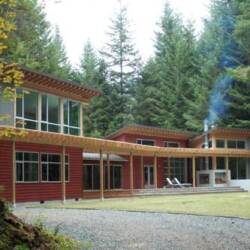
<box><xmin>16</xmin><ymin>90</ymin><xmax>38</xmax><ymax>129</ymax></box>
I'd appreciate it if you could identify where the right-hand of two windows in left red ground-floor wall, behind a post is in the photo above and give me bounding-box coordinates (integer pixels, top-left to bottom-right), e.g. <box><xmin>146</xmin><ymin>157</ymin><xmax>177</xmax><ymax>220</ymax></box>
<box><xmin>41</xmin><ymin>154</ymin><xmax>69</xmax><ymax>182</ymax></box>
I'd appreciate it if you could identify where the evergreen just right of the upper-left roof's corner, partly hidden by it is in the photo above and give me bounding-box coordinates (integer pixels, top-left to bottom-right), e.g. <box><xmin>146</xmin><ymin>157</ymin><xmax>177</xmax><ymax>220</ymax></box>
<box><xmin>73</xmin><ymin>41</ymin><xmax>112</xmax><ymax>137</ymax></box>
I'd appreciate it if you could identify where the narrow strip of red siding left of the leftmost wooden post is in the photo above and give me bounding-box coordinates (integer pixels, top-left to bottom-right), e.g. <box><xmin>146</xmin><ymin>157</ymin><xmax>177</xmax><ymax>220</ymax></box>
<box><xmin>0</xmin><ymin>140</ymin><xmax>12</xmax><ymax>201</ymax></box>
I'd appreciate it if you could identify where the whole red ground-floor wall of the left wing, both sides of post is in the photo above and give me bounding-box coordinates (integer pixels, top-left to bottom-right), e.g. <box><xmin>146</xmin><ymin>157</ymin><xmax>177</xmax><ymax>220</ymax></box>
<box><xmin>0</xmin><ymin>141</ymin><xmax>83</xmax><ymax>202</ymax></box>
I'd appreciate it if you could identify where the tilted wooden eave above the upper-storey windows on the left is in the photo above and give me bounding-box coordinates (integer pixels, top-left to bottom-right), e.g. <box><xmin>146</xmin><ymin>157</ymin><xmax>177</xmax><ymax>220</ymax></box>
<box><xmin>20</xmin><ymin>67</ymin><xmax>100</xmax><ymax>103</ymax></box>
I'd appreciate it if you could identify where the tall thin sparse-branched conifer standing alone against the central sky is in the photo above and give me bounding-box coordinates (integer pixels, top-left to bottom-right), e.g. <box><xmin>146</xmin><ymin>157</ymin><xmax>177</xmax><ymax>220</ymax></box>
<box><xmin>102</xmin><ymin>1</ymin><xmax>140</xmax><ymax>131</ymax></box>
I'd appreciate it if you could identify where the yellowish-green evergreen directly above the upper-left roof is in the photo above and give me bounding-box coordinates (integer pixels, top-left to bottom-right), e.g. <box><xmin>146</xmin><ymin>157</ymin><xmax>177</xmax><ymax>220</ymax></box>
<box><xmin>4</xmin><ymin>0</ymin><xmax>70</xmax><ymax>78</ymax></box>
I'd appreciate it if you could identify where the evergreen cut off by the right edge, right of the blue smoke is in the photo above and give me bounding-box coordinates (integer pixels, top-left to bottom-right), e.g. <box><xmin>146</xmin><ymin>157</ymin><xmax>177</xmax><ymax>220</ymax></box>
<box><xmin>224</xmin><ymin>0</ymin><xmax>250</xmax><ymax>128</ymax></box>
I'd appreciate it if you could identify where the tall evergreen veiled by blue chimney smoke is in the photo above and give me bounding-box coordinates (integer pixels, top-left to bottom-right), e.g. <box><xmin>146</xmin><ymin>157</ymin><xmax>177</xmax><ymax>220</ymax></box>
<box><xmin>200</xmin><ymin>0</ymin><xmax>242</xmax><ymax>126</ymax></box>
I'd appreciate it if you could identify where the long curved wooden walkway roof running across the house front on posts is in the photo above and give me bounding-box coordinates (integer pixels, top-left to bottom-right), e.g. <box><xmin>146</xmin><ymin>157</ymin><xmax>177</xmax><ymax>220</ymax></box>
<box><xmin>0</xmin><ymin>127</ymin><xmax>250</xmax><ymax>158</ymax></box>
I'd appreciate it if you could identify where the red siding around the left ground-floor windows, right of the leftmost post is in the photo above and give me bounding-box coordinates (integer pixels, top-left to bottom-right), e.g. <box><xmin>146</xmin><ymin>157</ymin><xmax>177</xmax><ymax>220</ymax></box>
<box><xmin>16</xmin><ymin>142</ymin><xmax>83</xmax><ymax>202</ymax></box>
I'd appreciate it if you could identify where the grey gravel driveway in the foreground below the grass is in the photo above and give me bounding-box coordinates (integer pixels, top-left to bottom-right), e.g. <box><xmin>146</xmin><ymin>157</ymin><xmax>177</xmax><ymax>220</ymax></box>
<box><xmin>15</xmin><ymin>208</ymin><xmax>250</xmax><ymax>250</ymax></box>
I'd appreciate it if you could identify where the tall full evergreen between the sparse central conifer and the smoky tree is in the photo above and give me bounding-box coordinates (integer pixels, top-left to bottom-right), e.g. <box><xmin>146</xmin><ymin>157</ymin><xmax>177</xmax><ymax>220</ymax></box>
<box><xmin>155</xmin><ymin>3</ymin><xmax>199</xmax><ymax>129</ymax></box>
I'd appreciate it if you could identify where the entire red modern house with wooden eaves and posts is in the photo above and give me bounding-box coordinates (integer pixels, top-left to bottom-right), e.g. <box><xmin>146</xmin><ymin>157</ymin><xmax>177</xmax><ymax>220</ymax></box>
<box><xmin>0</xmin><ymin>68</ymin><xmax>250</xmax><ymax>204</ymax></box>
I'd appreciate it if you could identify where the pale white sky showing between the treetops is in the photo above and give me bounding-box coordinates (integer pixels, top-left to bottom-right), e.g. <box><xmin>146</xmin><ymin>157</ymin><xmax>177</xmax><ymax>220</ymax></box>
<box><xmin>42</xmin><ymin>0</ymin><xmax>210</xmax><ymax>66</ymax></box>
